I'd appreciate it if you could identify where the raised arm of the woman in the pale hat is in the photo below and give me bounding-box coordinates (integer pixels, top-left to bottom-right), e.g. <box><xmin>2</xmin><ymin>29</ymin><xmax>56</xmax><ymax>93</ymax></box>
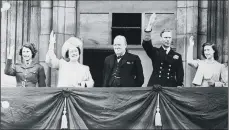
<box><xmin>45</xmin><ymin>31</ymin><xmax>59</xmax><ymax>68</ymax></box>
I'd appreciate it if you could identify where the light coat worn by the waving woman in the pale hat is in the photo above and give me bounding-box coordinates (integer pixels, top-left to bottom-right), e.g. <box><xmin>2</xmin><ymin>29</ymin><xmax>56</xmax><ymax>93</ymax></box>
<box><xmin>46</xmin><ymin>50</ymin><xmax>94</xmax><ymax>87</ymax></box>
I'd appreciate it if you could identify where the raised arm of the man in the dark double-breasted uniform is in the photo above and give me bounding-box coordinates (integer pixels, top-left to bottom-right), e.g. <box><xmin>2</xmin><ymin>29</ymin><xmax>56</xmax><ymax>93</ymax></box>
<box><xmin>142</xmin><ymin>13</ymin><xmax>156</xmax><ymax>60</ymax></box>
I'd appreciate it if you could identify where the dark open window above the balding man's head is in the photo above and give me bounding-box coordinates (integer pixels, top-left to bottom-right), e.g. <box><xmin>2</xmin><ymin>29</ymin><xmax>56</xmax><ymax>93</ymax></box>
<box><xmin>112</xmin><ymin>13</ymin><xmax>142</xmax><ymax>45</ymax></box>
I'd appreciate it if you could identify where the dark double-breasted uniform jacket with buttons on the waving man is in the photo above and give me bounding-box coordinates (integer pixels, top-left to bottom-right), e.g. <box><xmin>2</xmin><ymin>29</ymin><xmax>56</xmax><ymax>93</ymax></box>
<box><xmin>142</xmin><ymin>40</ymin><xmax>184</xmax><ymax>87</ymax></box>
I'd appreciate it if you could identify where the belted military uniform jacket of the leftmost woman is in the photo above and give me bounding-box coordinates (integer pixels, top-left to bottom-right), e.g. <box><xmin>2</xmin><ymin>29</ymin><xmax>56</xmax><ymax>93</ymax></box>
<box><xmin>5</xmin><ymin>59</ymin><xmax>46</xmax><ymax>87</ymax></box>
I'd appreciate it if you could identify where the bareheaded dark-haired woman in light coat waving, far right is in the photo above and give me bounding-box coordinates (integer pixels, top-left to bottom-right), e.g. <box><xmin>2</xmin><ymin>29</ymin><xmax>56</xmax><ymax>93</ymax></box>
<box><xmin>187</xmin><ymin>36</ymin><xmax>223</xmax><ymax>87</ymax></box>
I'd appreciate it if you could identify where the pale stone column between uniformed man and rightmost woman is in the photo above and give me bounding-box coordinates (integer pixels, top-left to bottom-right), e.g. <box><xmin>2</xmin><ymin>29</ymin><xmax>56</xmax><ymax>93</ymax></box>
<box><xmin>177</xmin><ymin>0</ymin><xmax>198</xmax><ymax>87</ymax></box>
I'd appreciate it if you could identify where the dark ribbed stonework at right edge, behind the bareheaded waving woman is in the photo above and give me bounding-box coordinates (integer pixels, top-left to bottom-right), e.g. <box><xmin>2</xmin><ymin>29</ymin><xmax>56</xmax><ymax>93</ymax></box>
<box><xmin>207</xmin><ymin>0</ymin><xmax>228</xmax><ymax>63</ymax></box>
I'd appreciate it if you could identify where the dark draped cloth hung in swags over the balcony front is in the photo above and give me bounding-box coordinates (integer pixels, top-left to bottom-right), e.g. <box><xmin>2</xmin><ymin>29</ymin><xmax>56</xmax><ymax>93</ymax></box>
<box><xmin>1</xmin><ymin>87</ymin><xmax>228</xmax><ymax>129</ymax></box>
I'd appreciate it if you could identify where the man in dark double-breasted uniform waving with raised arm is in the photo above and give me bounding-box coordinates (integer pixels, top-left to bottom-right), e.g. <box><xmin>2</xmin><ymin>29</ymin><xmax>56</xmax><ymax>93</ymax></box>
<box><xmin>142</xmin><ymin>14</ymin><xmax>184</xmax><ymax>87</ymax></box>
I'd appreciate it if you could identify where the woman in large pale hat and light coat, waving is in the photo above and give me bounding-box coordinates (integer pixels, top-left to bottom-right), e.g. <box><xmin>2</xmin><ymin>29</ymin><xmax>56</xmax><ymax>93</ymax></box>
<box><xmin>45</xmin><ymin>31</ymin><xmax>94</xmax><ymax>87</ymax></box>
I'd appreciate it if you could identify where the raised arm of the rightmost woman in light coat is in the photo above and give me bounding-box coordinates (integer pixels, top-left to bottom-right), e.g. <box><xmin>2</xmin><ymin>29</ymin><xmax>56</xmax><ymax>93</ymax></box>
<box><xmin>187</xmin><ymin>36</ymin><xmax>198</xmax><ymax>68</ymax></box>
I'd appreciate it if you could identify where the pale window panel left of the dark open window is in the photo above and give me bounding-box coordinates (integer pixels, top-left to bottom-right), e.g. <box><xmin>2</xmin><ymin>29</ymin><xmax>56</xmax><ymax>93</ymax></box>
<box><xmin>79</xmin><ymin>13</ymin><xmax>110</xmax><ymax>47</ymax></box>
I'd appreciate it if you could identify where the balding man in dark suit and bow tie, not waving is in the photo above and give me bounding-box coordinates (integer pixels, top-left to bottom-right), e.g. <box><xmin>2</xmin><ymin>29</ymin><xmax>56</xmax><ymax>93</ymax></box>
<box><xmin>103</xmin><ymin>35</ymin><xmax>144</xmax><ymax>87</ymax></box>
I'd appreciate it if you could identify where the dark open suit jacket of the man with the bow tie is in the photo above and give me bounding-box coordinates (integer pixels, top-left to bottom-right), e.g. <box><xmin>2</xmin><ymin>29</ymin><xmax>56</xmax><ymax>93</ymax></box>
<box><xmin>103</xmin><ymin>52</ymin><xmax>144</xmax><ymax>87</ymax></box>
